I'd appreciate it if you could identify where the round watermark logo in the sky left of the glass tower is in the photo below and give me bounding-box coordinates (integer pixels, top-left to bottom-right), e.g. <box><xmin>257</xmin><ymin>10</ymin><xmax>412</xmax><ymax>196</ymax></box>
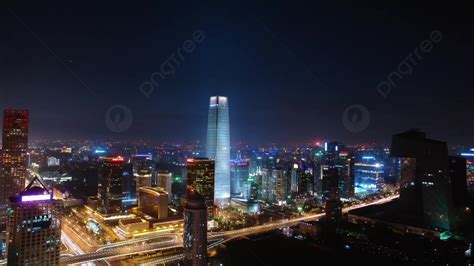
<box><xmin>105</xmin><ymin>104</ymin><xmax>133</xmax><ymax>133</ymax></box>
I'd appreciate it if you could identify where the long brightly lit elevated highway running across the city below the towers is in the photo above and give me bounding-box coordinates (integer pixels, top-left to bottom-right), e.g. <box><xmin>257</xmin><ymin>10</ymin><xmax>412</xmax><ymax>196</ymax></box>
<box><xmin>61</xmin><ymin>195</ymin><xmax>398</xmax><ymax>264</ymax></box>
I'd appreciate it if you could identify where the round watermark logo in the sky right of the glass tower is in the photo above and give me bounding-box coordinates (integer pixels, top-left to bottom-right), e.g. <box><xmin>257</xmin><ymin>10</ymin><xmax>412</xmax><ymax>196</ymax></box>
<box><xmin>342</xmin><ymin>104</ymin><xmax>370</xmax><ymax>133</ymax></box>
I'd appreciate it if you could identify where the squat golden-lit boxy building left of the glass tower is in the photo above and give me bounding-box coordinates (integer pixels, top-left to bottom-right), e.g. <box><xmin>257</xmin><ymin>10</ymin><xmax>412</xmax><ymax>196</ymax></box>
<box><xmin>138</xmin><ymin>187</ymin><xmax>169</xmax><ymax>220</ymax></box>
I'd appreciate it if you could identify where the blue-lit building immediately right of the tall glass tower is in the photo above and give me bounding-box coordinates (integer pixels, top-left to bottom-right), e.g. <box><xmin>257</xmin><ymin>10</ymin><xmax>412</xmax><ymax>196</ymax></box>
<box><xmin>230</xmin><ymin>159</ymin><xmax>249</xmax><ymax>198</ymax></box>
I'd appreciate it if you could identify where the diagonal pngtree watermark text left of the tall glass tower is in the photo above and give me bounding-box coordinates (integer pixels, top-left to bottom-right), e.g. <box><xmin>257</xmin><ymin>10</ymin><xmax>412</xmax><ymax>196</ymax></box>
<box><xmin>138</xmin><ymin>30</ymin><xmax>206</xmax><ymax>99</ymax></box>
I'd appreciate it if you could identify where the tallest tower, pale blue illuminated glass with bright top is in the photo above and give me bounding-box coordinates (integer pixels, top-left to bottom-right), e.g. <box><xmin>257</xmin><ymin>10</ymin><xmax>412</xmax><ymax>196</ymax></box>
<box><xmin>206</xmin><ymin>96</ymin><xmax>230</xmax><ymax>206</ymax></box>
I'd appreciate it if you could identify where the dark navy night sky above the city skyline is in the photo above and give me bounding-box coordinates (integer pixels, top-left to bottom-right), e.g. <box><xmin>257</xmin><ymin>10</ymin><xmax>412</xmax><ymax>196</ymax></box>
<box><xmin>0</xmin><ymin>1</ymin><xmax>474</xmax><ymax>144</ymax></box>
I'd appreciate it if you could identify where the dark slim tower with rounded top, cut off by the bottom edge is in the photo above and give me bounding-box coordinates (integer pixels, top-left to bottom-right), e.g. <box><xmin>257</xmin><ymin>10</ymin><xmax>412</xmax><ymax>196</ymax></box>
<box><xmin>183</xmin><ymin>189</ymin><xmax>207</xmax><ymax>266</ymax></box>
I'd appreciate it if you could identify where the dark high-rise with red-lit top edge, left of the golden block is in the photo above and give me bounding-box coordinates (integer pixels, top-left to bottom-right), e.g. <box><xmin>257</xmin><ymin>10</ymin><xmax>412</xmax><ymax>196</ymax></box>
<box><xmin>97</xmin><ymin>156</ymin><xmax>124</xmax><ymax>216</ymax></box>
